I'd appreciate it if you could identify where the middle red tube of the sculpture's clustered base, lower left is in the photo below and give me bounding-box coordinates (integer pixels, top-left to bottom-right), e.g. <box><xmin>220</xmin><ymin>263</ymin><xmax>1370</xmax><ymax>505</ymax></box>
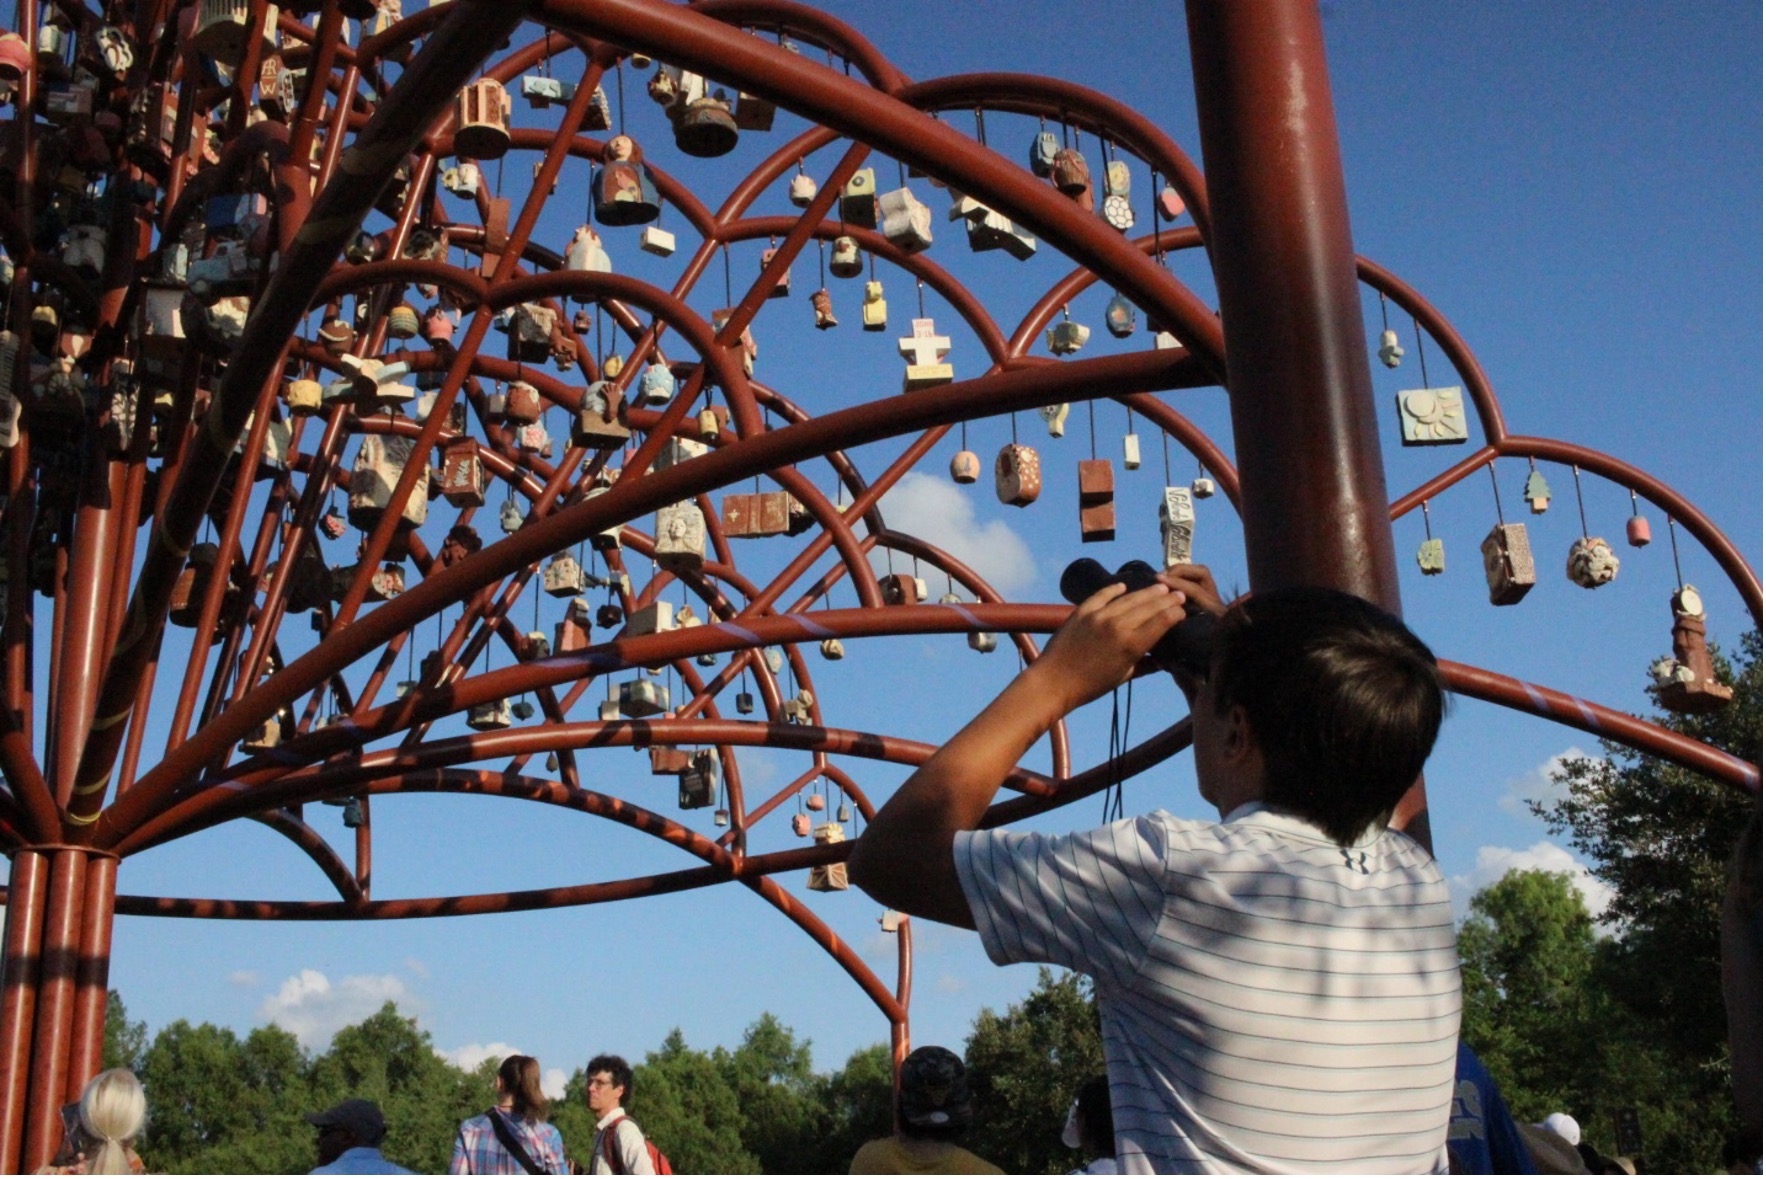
<box><xmin>25</xmin><ymin>849</ymin><xmax>87</xmax><ymax>1174</ymax></box>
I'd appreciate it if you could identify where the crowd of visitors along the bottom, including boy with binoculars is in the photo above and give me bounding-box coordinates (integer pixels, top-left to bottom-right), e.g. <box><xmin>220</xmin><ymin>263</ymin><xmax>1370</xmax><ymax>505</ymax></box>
<box><xmin>31</xmin><ymin>565</ymin><xmax>1761</xmax><ymax>1175</ymax></box>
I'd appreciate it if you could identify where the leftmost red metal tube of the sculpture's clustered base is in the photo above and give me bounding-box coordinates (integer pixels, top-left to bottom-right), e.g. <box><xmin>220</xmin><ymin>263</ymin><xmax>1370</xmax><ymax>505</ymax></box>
<box><xmin>0</xmin><ymin>851</ymin><xmax>49</xmax><ymax>1175</ymax></box>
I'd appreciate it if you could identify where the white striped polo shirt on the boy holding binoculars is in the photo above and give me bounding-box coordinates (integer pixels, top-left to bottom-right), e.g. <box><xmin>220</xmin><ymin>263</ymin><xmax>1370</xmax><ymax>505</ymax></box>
<box><xmin>955</xmin><ymin>803</ymin><xmax>1459</xmax><ymax>1174</ymax></box>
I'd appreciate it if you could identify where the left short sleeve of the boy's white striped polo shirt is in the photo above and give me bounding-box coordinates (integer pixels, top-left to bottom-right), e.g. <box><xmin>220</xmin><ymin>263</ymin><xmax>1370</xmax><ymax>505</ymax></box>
<box><xmin>952</xmin><ymin>815</ymin><xmax>1166</xmax><ymax>983</ymax></box>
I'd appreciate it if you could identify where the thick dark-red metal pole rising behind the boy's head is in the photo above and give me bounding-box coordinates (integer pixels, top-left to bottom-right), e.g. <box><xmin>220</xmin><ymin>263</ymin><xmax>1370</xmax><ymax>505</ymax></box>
<box><xmin>1189</xmin><ymin>0</ymin><xmax>1429</xmax><ymax>842</ymax></box>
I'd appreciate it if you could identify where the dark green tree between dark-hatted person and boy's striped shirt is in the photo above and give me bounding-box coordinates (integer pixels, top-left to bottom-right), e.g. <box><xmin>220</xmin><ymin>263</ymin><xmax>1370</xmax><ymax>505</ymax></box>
<box><xmin>964</xmin><ymin>967</ymin><xmax>1104</xmax><ymax>1174</ymax></box>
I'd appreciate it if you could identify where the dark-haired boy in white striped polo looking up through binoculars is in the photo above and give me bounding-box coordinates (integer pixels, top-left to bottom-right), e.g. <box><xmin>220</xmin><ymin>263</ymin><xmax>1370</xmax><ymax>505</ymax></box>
<box><xmin>848</xmin><ymin>565</ymin><xmax>1460</xmax><ymax>1174</ymax></box>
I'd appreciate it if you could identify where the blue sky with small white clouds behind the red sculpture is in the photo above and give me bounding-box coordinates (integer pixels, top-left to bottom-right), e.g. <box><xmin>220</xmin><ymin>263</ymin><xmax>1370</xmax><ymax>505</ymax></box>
<box><xmin>100</xmin><ymin>0</ymin><xmax>1761</xmax><ymax>1101</ymax></box>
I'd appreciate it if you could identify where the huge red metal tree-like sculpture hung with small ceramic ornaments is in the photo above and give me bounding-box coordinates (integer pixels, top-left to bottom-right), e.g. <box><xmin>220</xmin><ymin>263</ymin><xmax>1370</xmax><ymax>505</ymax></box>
<box><xmin>0</xmin><ymin>0</ymin><xmax>1761</xmax><ymax>1170</ymax></box>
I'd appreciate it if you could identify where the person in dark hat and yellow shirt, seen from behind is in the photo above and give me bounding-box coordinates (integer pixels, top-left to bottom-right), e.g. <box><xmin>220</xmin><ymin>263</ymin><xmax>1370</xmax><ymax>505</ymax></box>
<box><xmin>853</xmin><ymin>1047</ymin><xmax>1005</xmax><ymax>1175</ymax></box>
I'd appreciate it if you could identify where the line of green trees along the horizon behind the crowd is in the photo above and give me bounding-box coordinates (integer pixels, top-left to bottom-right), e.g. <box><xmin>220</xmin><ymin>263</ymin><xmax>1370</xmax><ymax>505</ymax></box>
<box><xmin>104</xmin><ymin>632</ymin><xmax>1761</xmax><ymax>1174</ymax></box>
